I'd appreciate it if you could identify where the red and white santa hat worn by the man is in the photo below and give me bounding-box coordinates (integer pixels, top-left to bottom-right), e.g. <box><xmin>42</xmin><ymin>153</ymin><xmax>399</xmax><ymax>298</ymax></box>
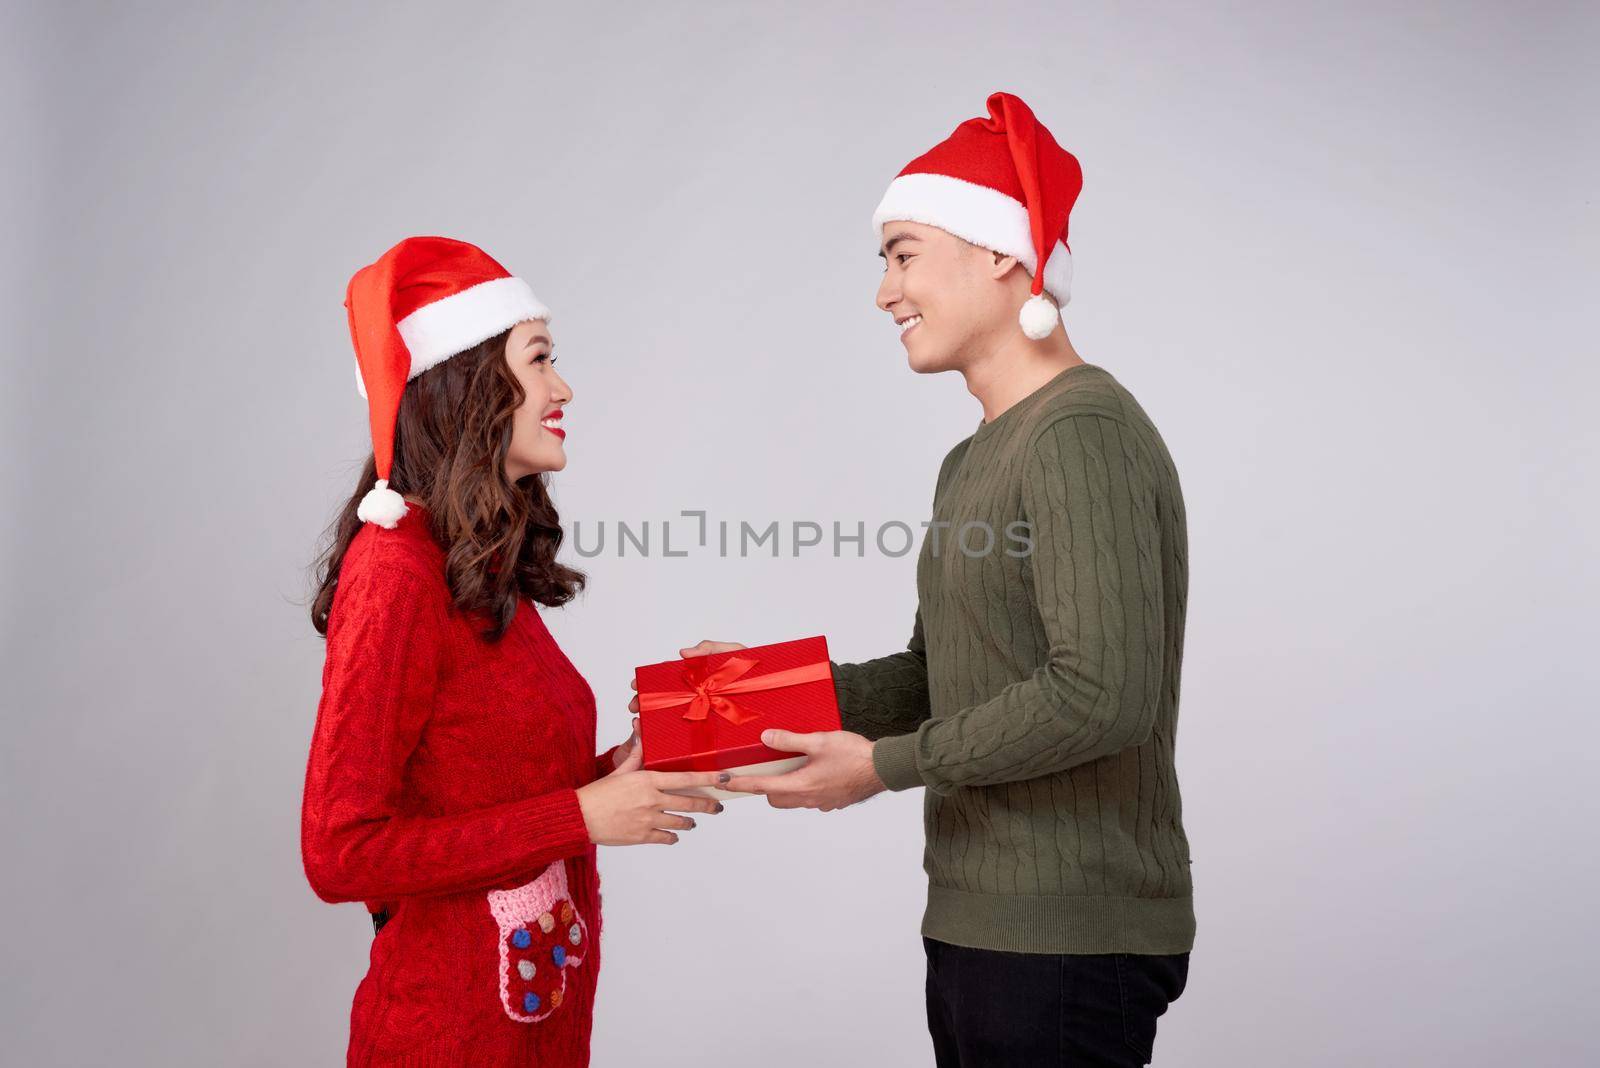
<box><xmin>872</xmin><ymin>93</ymin><xmax>1083</xmax><ymax>341</ymax></box>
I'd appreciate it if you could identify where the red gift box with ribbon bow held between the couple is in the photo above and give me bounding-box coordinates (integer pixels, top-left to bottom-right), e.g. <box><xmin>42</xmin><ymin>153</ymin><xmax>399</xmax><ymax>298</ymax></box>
<box><xmin>634</xmin><ymin>635</ymin><xmax>840</xmax><ymax>796</ymax></box>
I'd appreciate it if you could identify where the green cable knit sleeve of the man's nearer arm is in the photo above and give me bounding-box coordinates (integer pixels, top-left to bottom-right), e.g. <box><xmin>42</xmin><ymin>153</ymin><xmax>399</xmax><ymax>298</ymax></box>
<box><xmin>872</xmin><ymin>414</ymin><xmax>1163</xmax><ymax>793</ymax></box>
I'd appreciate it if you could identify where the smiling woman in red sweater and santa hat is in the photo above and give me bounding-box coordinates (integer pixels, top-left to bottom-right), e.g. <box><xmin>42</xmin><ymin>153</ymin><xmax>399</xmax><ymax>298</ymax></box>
<box><xmin>301</xmin><ymin>238</ymin><xmax>726</xmax><ymax>1066</ymax></box>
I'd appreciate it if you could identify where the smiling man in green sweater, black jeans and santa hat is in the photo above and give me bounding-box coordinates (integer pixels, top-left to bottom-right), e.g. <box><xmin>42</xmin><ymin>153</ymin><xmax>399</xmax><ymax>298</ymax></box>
<box><xmin>646</xmin><ymin>93</ymin><xmax>1195</xmax><ymax>1068</ymax></box>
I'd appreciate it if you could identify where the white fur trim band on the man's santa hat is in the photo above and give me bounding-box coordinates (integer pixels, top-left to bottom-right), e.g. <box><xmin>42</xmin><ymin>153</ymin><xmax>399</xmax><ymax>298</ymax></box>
<box><xmin>872</xmin><ymin>174</ymin><xmax>1072</xmax><ymax>305</ymax></box>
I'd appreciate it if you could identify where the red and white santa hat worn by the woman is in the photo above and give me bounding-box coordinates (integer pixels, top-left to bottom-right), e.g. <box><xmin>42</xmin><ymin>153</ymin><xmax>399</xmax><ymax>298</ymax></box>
<box><xmin>344</xmin><ymin>237</ymin><xmax>550</xmax><ymax>528</ymax></box>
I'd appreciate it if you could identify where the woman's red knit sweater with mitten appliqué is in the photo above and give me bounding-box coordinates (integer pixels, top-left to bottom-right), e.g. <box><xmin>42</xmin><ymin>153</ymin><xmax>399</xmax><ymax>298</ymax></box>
<box><xmin>301</xmin><ymin>505</ymin><xmax>611</xmax><ymax>1068</ymax></box>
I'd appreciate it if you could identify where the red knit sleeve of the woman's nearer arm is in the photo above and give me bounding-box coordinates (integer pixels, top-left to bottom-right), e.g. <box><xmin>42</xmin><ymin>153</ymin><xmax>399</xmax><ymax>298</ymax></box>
<box><xmin>301</xmin><ymin>558</ymin><xmax>589</xmax><ymax>902</ymax></box>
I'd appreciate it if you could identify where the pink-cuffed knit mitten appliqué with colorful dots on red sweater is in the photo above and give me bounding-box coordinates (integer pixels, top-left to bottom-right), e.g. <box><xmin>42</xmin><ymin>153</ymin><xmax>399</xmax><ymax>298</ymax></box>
<box><xmin>490</xmin><ymin>860</ymin><xmax>589</xmax><ymax>1023</ymax></box>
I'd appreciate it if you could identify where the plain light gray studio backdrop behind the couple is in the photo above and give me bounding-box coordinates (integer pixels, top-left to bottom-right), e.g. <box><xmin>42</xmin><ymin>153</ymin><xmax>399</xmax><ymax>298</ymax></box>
<box><xmin>0</xmin><ymin>3</ymin><xmax>1600</xmax><ymax>1068</ymax></box>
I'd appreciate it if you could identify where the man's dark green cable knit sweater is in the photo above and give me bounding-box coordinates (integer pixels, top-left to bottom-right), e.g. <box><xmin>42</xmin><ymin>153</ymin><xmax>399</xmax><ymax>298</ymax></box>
<box><xmin>835</xmin><ymin>365</ymin><xmax>1195</xmax><ymax>953</ymax></box>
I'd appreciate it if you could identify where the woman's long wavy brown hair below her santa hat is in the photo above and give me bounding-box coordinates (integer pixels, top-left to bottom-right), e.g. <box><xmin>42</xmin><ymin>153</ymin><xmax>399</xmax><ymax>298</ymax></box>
<box><xmin>310</xmin><ymin>331</ymin><xmax>584</xmax><ymax>641</ymax></box>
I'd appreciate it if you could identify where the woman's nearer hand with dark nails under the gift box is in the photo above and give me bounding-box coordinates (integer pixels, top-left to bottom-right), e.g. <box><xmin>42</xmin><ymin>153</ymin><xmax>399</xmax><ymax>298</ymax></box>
<box><xmin>578</xmin><ymin>745</ymin><xmax>728</xmax><ymax>846</ymax></box>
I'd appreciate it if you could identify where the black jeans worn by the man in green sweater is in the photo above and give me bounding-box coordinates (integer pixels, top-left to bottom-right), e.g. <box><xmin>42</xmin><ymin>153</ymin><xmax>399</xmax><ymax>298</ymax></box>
<box><xmin>922</xmin><ymin>938</ymin><xmax>1189</xmax><ymax>1068</ymax></box>
